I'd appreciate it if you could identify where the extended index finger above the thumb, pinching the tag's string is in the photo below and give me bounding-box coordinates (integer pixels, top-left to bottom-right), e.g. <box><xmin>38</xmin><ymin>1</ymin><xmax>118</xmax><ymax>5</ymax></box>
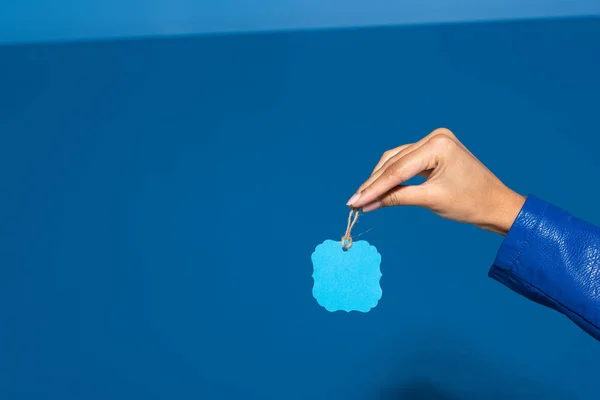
<box><xmin>351</xmin><ymin>146</ymin><xmax>436</xmax><ymax>208</ymax></box>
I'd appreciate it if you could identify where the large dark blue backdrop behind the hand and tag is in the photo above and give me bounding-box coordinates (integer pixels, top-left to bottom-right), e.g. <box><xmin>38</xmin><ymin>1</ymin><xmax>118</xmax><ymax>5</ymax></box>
<box><xmin>0</xmin><ymin>14</ymin><xmax>600</xmax><ymax>400</ymax></box>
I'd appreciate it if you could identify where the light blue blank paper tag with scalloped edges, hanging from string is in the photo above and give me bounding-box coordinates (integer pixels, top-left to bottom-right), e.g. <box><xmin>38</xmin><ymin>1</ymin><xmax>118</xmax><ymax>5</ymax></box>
<box><xmin>311</xmin><ymin>240</ymin><xmax>382</xmax><ymax>313</ymax></box>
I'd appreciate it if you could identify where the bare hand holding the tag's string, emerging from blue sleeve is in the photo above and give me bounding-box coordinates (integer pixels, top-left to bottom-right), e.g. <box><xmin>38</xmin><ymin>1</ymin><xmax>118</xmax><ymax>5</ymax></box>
<box><xmin>348</xmin><ymin>128</ymin><xmax>525</xmax><ymax>235</ymax></box>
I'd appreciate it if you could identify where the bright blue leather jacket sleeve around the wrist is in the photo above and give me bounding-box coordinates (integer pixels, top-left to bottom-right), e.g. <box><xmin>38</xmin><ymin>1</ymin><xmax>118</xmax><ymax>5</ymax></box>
<box><xmin>489</xmin><ymin>196</ymin><xmax>600</xmax><ymax>340</ymax></box>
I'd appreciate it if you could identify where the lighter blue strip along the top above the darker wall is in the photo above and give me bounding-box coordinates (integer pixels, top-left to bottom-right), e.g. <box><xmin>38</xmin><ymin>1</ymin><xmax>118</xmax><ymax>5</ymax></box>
<box><xmin>0</xmin><ymin>0</ymin><xmax>600</xmax><ymax>43</ymax></box>
